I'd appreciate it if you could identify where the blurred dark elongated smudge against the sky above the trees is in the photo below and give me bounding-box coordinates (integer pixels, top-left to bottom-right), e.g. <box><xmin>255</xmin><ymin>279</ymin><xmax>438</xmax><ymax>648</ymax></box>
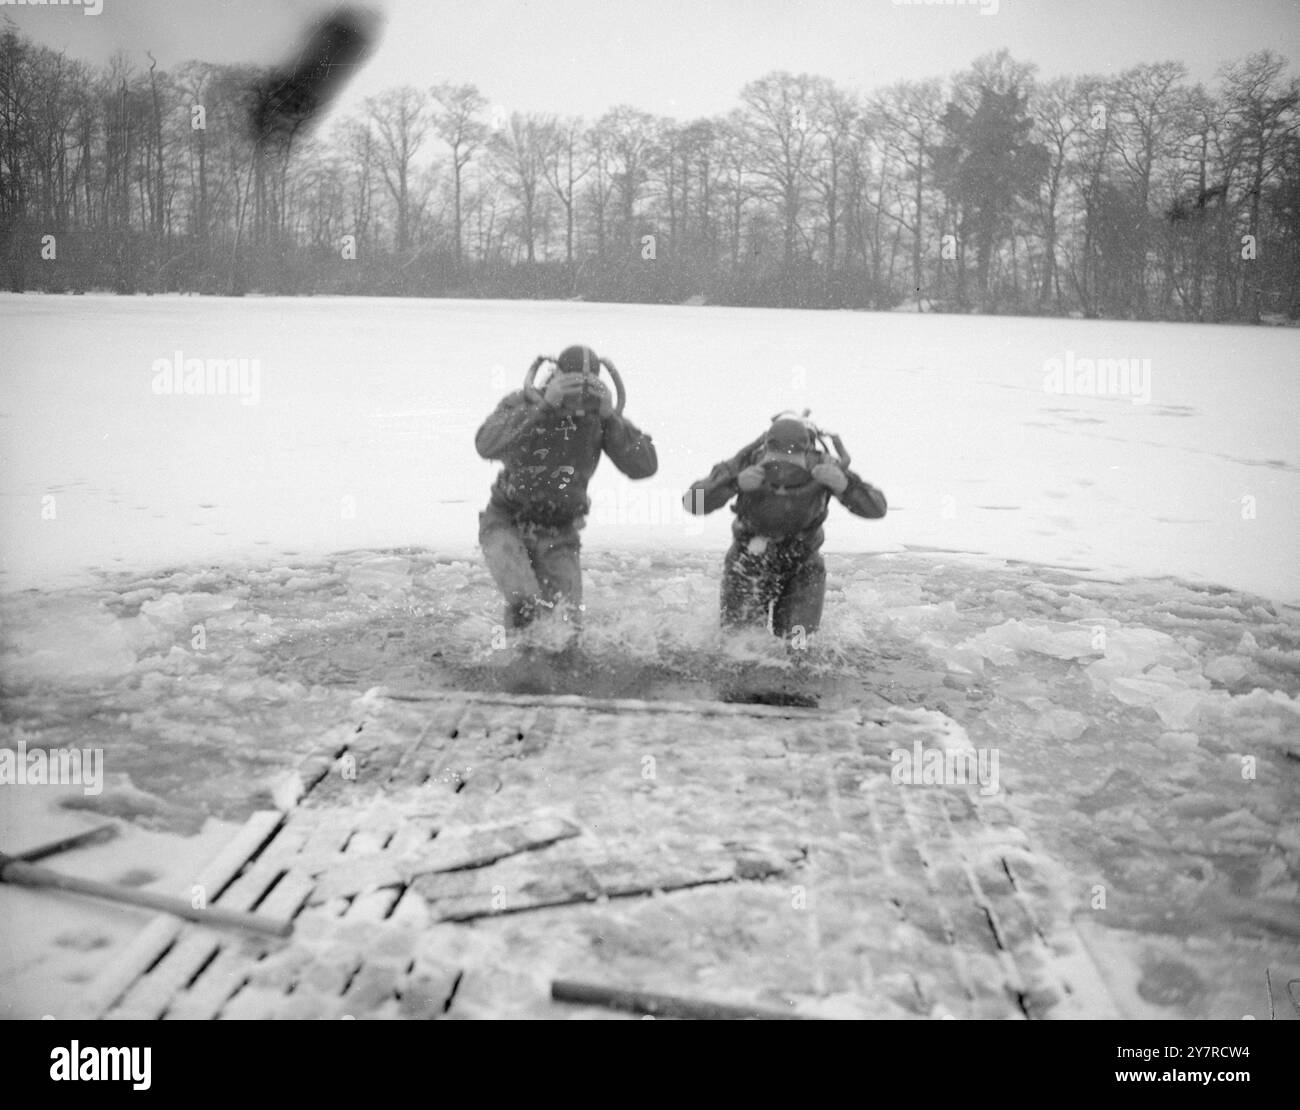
<box><xmin>251</xmin><ymin>8</ymin><xmax>380</xmax><ymax>146</ymax></box>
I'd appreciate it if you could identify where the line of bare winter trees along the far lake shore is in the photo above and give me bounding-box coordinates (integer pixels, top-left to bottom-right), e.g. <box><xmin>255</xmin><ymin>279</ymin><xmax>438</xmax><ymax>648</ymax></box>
<box><xmin>0</xmin><ymin>25</ymin><xmax>1300</xmax><ymax>321</ymax></box>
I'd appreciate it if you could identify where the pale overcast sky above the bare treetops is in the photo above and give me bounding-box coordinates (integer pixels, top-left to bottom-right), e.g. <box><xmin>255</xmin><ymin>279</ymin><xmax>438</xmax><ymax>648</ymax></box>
<box><xmin>10</xmin><ymin>0</ymin><xmax>1300</xmax><ymax>120</ymax></box>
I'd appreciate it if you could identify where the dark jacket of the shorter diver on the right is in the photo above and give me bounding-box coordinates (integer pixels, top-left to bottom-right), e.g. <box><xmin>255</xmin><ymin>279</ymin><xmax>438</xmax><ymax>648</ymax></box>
<box><xmin>683</xmin><ymin>441</ymin><xmax>888</xmax><ymax>552</ymax></box>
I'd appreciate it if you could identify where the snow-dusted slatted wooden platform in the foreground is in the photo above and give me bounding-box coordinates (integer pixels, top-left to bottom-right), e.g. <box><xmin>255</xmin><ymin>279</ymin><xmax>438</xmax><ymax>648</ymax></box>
<box><xmin>76</xmin><ymin>690</ymin><xmax>1118</xmax><ymax>1019</ymax></box>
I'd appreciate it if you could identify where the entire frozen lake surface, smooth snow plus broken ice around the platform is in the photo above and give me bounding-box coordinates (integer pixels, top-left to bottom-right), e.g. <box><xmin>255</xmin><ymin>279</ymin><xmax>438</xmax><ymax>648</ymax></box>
<box><xmin>0</xmin><ymin>298</ymin><xmax>1300</xmax><ymax>1016</ymax></box>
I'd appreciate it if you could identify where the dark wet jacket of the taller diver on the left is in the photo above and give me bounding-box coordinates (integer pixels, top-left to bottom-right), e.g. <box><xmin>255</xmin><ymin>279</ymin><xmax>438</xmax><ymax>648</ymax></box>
<box><xmin>475</xmin><ymin>390</ymin><xmax>659</xmax><ymax>528</ymax></box>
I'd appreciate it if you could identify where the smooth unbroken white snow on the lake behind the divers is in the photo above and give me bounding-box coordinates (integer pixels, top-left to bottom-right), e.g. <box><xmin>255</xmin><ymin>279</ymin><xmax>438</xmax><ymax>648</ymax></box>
<box><xmin>0</xmin><ymin>295</ymin><xmax>1300</xmax><ymax>602</ymax></box>
